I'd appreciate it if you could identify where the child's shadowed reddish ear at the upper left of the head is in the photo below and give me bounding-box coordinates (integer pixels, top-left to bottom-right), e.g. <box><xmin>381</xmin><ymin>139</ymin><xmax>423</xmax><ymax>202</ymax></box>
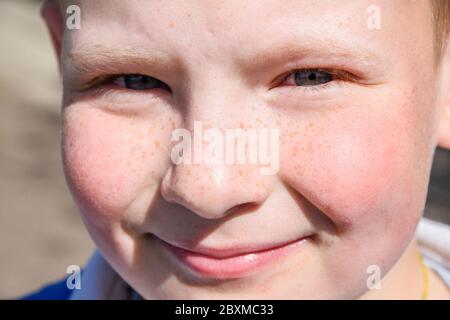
<box><xmin>41</xmin><ymin>0</ymin><xmax>64</xmax><ymax>65</ymax></box>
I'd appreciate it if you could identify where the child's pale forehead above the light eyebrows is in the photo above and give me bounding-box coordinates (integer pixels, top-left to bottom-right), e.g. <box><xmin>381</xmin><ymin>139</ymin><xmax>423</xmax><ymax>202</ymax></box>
<box><xmin>64</xmin><ymin>0</ymin><xmax>432</xmax><ymax>69</ymax></box>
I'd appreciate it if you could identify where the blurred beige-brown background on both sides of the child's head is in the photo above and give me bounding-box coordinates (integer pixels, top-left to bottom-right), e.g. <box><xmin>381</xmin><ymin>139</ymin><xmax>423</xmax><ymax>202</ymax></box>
<box><xmin>0</xmin><ymin>0</ymin><xmax>450</xmax><ymax>299</ymax></box>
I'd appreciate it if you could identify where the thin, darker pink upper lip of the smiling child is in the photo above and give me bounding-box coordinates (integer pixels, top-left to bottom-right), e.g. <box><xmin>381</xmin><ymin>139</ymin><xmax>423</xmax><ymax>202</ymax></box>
<box><xmin>153</xmin><ymin>236</ymin><xmax>308</xmax><ymax>259</ymax></box>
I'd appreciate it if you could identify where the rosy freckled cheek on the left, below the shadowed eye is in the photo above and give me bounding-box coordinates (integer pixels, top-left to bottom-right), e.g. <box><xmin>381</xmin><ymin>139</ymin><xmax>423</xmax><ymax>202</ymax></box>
<box><xmin>63</xmin><ymin>105</ymin><xmax>175</xmax><ymax>223</ymax></box>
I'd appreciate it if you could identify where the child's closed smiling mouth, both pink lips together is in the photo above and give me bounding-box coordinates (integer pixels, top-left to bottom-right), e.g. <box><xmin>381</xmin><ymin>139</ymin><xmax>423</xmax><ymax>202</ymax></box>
<box><xmin>158</xmin><ymin>236</ymin><xmax>311</xmax><ymax>279</ymax></box>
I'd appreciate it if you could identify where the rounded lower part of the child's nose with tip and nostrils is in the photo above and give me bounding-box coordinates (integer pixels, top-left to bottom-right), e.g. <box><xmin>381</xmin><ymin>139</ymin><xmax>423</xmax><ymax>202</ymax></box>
<box><xmin>161</xmin><ymin>154</ymin><xmax>272</xmax><ymax>219</ymax></box>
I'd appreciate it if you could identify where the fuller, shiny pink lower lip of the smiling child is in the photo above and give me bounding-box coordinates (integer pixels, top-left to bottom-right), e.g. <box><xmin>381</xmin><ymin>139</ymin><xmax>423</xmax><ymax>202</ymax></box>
<box><xmin>163</xmin><ymin>238</ymin><xmax>307</xmax><ymax>279</ymax></box>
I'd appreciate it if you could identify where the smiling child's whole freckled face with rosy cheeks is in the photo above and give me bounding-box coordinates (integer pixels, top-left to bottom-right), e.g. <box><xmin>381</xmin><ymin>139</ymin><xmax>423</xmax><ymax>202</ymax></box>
<box><xmin>57</xmin><ymin>0</ymin><xmax>450</xmax><ymax>299</ymax></box>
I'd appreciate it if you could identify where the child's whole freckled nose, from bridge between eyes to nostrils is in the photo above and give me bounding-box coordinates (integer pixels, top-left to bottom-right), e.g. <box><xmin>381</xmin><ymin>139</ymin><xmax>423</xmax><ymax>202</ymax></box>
<box><xmin>161</xmin><ymin>82</ymin><xmax>273</xmax><ymax>219</ymax></box>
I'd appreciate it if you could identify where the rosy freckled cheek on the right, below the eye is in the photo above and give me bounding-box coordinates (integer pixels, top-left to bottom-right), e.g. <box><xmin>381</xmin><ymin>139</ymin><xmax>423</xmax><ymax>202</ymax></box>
<box><xmin>281</xmin><ymin>115</ymin><xmax>413</xmax><ymax>225</ymax></box>
